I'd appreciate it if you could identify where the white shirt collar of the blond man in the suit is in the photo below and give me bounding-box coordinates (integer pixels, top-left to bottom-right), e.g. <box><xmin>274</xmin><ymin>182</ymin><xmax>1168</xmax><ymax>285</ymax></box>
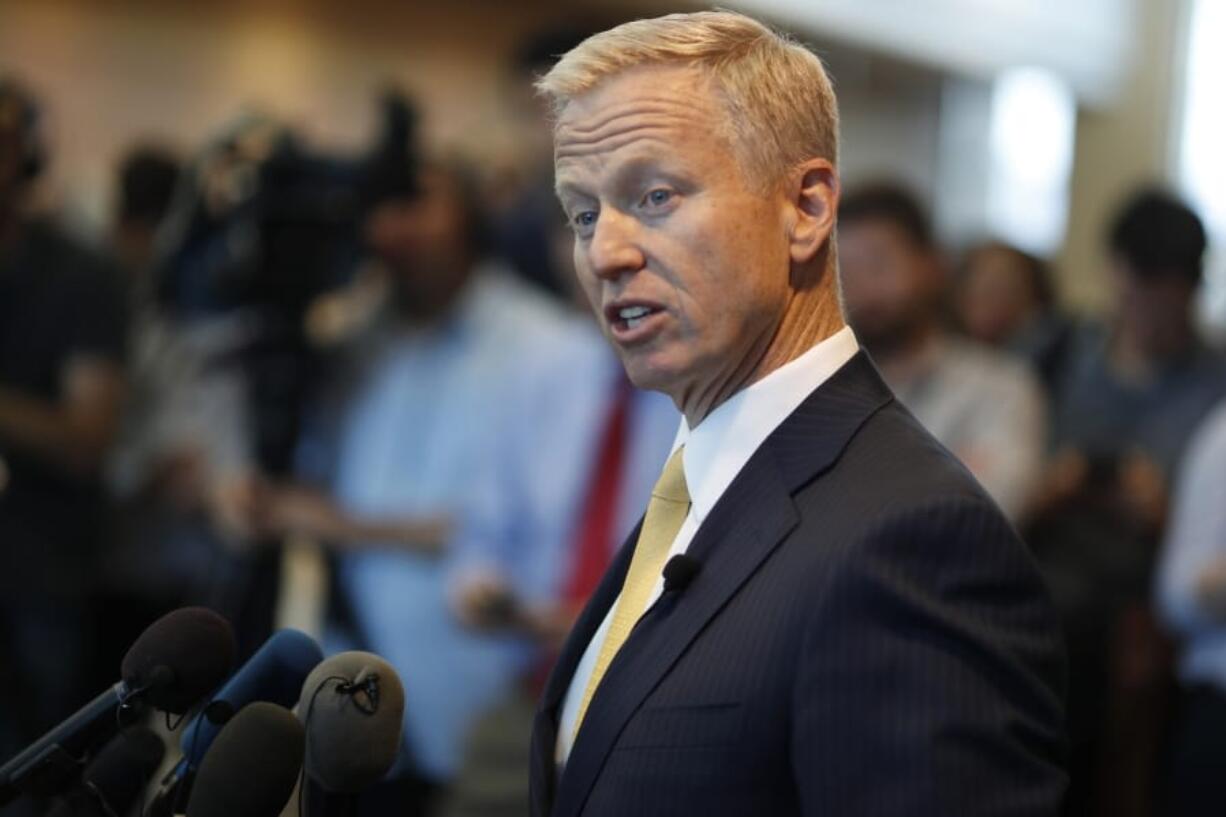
<box><xmin>672</xmin><ymin>326</ymin><xmax>859</xmax><ymax>523</ymax></box>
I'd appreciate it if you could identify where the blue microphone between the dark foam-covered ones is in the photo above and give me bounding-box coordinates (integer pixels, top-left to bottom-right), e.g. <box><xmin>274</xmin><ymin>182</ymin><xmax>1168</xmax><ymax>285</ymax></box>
<box><xmin>146</xmin><ymin>629</ymin><xmax>324</xmax><ymax>817</ymax></box>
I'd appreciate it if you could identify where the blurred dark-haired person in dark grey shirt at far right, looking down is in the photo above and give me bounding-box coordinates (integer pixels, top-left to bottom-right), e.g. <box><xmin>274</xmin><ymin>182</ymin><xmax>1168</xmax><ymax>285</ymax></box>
<box><xmin>1052</xmin><ymin>190</ymin><xmax>1226</xmax><ymax>483</ymax></box>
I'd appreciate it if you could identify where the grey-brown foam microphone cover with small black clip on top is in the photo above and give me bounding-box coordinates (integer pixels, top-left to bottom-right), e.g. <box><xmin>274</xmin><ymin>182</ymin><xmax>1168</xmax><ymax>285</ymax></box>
<box><xmin>298</xmin><ymin>650</ymin><xmax>405</xmax><ymax>792</ymax></box>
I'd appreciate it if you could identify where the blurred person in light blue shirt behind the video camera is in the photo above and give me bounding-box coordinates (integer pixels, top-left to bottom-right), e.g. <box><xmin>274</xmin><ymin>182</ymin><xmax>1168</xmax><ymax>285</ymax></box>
<box><xmin>232</xmin><ymin>162</ymin><xmax>593</xmax><ymax>815</ymax></box>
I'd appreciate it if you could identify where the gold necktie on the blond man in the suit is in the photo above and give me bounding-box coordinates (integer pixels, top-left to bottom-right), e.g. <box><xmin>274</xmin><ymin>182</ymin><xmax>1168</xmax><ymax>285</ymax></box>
<box><xmin>575</xmin><ymin>445</ymin><xmax>690</xmax><ymax>735</ymax></box>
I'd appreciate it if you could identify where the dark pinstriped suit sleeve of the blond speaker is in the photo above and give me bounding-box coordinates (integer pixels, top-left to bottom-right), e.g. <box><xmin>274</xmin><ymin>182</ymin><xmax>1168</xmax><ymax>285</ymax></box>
<box><xmin>791</xmin><ymin>498</ymin><xmax>1067</xmax><ymax>817</ymax></box>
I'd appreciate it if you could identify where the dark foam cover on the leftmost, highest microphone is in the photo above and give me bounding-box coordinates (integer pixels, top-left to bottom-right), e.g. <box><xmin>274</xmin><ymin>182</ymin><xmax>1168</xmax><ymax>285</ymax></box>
<box><xmin>120</xmin><ymin>607</ymin><xmax>238</xmax><ymax>715</ymax></box>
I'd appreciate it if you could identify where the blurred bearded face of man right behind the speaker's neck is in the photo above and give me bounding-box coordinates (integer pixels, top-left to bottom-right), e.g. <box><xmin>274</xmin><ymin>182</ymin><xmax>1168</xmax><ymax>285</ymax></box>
<box><xmin>839</xmin><ymin>218</ymin><xmax>935</xmax><ymax>352</ymax></box>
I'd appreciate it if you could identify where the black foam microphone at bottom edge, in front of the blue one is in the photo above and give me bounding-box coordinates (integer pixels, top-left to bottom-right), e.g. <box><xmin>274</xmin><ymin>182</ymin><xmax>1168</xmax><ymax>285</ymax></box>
<box><xmin>186</xmin><ymin>700</ymin><xmax>305</xmax><ymax>817</ymax></box>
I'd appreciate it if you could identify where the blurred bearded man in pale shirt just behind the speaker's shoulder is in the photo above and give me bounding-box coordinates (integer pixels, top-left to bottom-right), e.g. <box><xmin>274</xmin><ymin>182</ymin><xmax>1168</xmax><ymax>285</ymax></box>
<box><xmin>839</xmin><ymin>184</ymin><xmax>1046</xmax><ymax>519</ymax></box>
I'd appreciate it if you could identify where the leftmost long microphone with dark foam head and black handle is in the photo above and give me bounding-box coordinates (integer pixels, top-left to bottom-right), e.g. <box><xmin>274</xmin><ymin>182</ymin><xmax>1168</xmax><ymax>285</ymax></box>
<box><xmin>0</xmin><ymin>607</ymin><xmax>237</xmax><ymax>806</ymax></box>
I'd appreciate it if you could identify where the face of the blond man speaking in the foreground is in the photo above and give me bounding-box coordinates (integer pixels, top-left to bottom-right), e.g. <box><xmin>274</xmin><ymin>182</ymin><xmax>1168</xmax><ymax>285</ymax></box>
<box><xmin>554</xmin><ymin>65</ymin><xmax>791</xmax><ymax>410</ymax></box>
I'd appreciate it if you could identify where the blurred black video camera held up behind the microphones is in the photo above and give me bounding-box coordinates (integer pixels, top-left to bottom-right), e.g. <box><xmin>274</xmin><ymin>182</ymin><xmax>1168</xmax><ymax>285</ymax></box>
<box><xmin>154</xmin><ymin>91</ymin><xmax>418</xmax><ymax>474</ymax></box>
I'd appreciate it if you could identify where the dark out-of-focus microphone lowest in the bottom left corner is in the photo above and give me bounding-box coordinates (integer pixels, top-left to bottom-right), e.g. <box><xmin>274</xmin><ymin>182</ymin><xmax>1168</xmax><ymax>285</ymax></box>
<box><xmin>47</xmin><ymin>726</ymin><xmax>166</xmax><ymax>817</ymax></box>
